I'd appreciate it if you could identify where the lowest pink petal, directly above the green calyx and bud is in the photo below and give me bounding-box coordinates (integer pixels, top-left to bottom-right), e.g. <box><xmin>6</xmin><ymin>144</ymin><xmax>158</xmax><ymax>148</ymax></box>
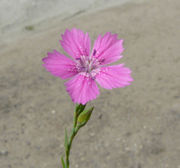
<box><xmin>65</xmin><ymin>74</ymin><xmax>99</xmax><ymax>104</ymax></box>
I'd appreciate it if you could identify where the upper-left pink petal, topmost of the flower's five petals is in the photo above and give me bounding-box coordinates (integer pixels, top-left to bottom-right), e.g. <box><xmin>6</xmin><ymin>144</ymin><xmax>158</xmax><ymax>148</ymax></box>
<box><xmin>60</xmin><ymin>28</ymin><xmax>90</xmax><ymax>59</ymax></box>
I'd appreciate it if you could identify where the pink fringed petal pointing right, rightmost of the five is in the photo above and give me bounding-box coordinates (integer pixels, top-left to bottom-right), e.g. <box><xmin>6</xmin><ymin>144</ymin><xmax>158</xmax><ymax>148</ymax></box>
<box><xmin>96</xmin><ymin>64</ymin><xmax>133</xmax><ymax>89</ymax></box>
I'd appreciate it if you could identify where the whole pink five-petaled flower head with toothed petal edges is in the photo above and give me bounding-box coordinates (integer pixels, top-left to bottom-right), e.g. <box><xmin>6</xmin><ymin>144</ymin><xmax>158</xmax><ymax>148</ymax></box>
<box><xmin>43</xmin><ymin>28</ymin><xmax>133</xmax><ymax>104</ymax></box>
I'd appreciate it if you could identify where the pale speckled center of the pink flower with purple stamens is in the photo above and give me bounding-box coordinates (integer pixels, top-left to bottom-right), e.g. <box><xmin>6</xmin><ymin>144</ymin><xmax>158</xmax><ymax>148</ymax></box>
<box><xmin>76</xmin><ymin>55</ymin><xmax>99</xmax><ymax>77</ymax></box>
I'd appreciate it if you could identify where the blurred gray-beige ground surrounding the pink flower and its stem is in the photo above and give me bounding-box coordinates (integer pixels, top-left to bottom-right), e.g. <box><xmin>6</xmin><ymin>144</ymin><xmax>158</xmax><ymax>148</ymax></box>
<box><xmin>0</xmin><ymin>0</ymin><xmax>180</xmax><ymax>168</ymax></box>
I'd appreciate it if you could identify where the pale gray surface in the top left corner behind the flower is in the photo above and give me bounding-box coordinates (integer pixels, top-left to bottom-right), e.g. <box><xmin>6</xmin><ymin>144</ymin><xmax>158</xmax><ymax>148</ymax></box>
<box><xmin>0</xmin><ymin>0</ymin><xmax>132</xmax><ymax>43</ymax></box>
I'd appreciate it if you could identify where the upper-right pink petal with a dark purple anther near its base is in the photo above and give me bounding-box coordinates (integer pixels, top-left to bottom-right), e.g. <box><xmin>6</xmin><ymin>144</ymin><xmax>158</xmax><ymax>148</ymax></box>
<box><xmin>92</xmin><ymin>32</ymin><xmax>124</xmax><ymax>65</ymax></box>
